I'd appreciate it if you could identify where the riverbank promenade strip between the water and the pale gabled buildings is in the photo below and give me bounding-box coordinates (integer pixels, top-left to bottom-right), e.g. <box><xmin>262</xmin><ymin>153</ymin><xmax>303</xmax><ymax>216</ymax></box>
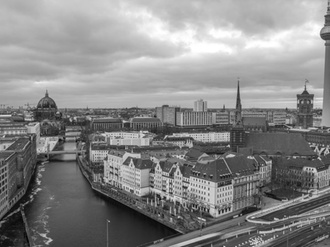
<box><xmin>77</xmin><ymin>156</ymin><xmax>188</xmax><ymax>234</ymax></box>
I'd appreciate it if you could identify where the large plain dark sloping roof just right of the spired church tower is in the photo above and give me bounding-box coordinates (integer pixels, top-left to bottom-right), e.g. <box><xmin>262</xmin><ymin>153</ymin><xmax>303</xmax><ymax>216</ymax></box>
<box><xmin>246</xmin><ymin>133</ymin><xmax>315</xmax><ymax>156</ymax></box>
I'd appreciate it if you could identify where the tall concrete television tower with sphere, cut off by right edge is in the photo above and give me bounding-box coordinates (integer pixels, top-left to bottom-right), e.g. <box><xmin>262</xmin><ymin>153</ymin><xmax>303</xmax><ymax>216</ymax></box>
<box><xmin>320</xmin><ymin>0</ymin><xmax>330</xmax><ymax>127</ymax></box>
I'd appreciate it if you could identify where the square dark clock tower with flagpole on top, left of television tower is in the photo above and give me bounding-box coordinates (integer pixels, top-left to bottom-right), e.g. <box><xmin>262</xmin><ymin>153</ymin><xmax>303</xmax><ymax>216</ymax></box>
<box><xmin>297</xmin><ymin>83</ymin><xmax>314</xmax><ymax>129</ymax></box>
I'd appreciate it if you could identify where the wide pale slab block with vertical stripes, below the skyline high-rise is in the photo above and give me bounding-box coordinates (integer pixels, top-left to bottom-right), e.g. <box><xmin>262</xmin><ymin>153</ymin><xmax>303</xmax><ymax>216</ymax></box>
<box><xmin>176</xmin><ymin>111</ymin><xmax>212</xmax><ymax>127</ymax></box>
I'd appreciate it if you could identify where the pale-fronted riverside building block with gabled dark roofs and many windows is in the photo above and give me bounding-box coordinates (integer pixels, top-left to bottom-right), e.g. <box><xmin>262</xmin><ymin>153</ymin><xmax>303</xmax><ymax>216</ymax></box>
<box><xmin>103</xmin><ymin>147</ymin><xmax>269</xmax><ymax>217</ymax></box>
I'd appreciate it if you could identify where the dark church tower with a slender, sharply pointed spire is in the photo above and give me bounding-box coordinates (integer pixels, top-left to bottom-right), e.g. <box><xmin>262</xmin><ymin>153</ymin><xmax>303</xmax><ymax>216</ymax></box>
<box><xmin>230</xmin><ymin>80</ymin><xmax>245</xmax><ymax>152</ymax></box>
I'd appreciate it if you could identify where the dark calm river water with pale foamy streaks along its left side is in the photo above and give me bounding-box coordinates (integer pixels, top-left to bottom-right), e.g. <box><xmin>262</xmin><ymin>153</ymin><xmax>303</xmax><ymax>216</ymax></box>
<box><xmin>0</xmin><ymin>142</ymin><xmax>175</xmax><ymax>247</ymax></box>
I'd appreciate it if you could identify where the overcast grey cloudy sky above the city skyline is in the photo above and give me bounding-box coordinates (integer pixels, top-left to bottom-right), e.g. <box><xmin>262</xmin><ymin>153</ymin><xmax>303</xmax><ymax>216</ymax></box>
<box><xmin>0</xmin><ymin>0</ymin><xmax>327</xmax><ymax>108</ymax></box>
